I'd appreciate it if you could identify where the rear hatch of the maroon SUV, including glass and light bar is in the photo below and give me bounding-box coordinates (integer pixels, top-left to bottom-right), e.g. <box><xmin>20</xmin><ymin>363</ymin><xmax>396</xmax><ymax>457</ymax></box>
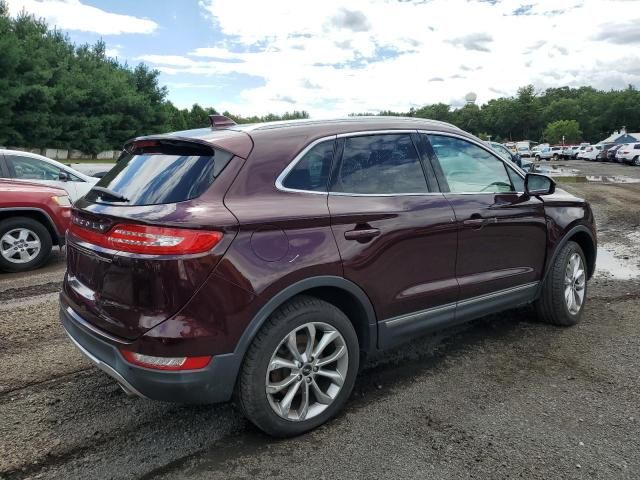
<box><xmin>63</xmin><ymin>133</ymin><xmax>250</xmax><ymax>340</ymax></box>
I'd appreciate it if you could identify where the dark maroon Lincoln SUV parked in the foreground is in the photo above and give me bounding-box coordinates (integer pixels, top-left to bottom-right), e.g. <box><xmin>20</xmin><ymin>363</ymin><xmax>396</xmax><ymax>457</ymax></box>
<box><xmin>60</xmin><ymin>117</ymin><xmax>596</xmax><ymax>436</ymax></box>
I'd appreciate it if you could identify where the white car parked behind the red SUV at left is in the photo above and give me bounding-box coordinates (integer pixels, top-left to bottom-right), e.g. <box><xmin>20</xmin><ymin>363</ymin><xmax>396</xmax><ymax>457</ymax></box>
<box><xmin>0</xmin><ymin>150</ymin><xmax>100</xmax><ymax>202</ymax></box>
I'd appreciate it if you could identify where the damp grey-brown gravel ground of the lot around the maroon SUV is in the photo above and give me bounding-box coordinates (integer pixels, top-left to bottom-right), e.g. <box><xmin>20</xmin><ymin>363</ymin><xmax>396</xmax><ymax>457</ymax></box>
<box><xmin>0</xmin><ymin>161</ymin><xmax>640</xmax><ymax>479</ymax></box>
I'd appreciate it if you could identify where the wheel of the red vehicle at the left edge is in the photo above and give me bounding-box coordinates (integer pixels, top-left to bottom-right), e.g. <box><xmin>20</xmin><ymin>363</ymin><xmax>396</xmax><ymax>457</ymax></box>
<box><xmin>0</xmin><ymin>217</ymin><xmax>52</xmax><ymax>272</ymax></box>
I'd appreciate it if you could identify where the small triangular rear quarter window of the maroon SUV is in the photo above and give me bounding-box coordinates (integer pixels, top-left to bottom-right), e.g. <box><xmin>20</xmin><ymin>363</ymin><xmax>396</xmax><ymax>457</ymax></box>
<box><xmin>282</xmin><ymin>140</ymin><xmax>335</xmax><ymax>192</ymax></box>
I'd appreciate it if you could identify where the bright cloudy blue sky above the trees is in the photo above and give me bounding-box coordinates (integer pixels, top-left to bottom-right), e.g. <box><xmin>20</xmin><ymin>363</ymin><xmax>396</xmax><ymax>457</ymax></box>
<box><xmin>8</xmin><ymin>0</ymin><xmax>640</xmax><ymax>117</ymax></box>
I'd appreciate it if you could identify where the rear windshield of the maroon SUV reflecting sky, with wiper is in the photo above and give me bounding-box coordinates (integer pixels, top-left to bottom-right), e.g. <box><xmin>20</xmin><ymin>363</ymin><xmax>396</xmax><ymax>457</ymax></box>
<box><xmin>86</xmin><ymin>142</ymin><xmax>233</xmax><ymax>206</ymax></box>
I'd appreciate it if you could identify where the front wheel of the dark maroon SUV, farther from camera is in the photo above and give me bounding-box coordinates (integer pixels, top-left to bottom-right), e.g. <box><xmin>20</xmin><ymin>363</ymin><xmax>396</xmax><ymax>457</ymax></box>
<box><xmin>534</xmin><ymin>241</ymin><xmax>587</xmax><ymax>327</ymax></box>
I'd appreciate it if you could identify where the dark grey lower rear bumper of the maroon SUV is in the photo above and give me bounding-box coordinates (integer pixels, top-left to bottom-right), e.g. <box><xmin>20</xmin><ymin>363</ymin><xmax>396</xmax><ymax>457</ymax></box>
<box><xmin>60</xmin><ymin>302</ymin><xmax>241</xmax><ymax>403</ymax></box>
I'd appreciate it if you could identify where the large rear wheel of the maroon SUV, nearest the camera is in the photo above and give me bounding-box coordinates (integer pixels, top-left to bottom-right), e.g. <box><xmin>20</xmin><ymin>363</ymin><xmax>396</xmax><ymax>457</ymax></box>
<box><xmin>237</xmin><ymin>296</ymin><xmax>360</xmax><ymax>437</ymax></box>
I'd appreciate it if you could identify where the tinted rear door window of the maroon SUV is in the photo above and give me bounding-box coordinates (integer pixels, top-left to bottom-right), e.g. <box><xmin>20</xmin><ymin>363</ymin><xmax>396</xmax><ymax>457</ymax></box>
<box><xmin>331</xmin><ymin>134</ymin><xmax>427</xmax><ymax>194</ymax></box>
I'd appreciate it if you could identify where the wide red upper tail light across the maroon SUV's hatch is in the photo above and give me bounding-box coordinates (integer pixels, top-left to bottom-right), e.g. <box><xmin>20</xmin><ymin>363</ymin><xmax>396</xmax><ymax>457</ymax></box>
<box><xmin>70</xmin><ymin>218</ymin><xmax>222</xmax><ymax>255</ymax></box>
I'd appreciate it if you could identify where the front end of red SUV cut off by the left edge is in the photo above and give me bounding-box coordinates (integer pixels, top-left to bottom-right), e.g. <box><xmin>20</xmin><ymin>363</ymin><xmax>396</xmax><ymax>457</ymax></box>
<box><xmin>0</xmin><ymin>179</ymin><xmax>71</xmax><ymax>272</ymax></box>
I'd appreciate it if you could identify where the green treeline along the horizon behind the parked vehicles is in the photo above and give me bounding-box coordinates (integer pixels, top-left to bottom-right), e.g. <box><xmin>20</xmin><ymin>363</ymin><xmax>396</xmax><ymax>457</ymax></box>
<box><xmin>0</xmin><ymin>0</ymin><xmax>640</xmax><ymax>153</ymax></box>
